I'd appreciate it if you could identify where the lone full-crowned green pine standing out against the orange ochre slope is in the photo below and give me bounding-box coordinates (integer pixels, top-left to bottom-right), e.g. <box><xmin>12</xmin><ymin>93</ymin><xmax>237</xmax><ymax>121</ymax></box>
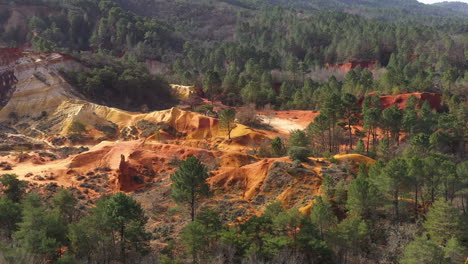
<box><xmin>171</xmin><ymin>156</ymin><xmax>211</xmax><ymax>221</ymax></box>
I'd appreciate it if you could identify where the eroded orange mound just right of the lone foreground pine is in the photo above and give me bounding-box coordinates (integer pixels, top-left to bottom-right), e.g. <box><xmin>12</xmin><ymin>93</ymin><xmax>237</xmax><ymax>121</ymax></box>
<box><xmin>210</xmin><ymin>158</ymin><xmax>322</xmax><ymax>210</ymax></box>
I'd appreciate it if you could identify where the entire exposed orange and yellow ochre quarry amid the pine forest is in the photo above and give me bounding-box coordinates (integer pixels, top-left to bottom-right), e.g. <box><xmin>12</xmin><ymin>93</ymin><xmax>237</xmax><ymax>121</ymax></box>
<box><xmin>0</xmin><ymin>50</ymin><xmax>380</xmax><ymax>235</ymax></box>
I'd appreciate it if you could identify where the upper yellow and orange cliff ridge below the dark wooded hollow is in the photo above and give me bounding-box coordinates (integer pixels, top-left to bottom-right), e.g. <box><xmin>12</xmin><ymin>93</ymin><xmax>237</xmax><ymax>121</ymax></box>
<box><xmin>0</xmin><ymin>49</ymin><xmax>266</xmax><ymax>145</ymax></box>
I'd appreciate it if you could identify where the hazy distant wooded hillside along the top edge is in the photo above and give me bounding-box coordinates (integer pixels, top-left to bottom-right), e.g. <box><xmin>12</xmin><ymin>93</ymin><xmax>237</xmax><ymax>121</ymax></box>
<box><xmin>117</xmin><ymin>0</ymin><xmax>466</xmax><ymax>20</ymax></box>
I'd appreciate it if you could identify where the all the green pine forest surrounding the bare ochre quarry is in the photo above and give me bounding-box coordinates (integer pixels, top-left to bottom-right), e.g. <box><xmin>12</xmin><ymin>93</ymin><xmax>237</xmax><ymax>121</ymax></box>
<box><xmin>0</xmin><ymin>0</ymin><xmax>468</xmax><ymax>264</ymax></box>
